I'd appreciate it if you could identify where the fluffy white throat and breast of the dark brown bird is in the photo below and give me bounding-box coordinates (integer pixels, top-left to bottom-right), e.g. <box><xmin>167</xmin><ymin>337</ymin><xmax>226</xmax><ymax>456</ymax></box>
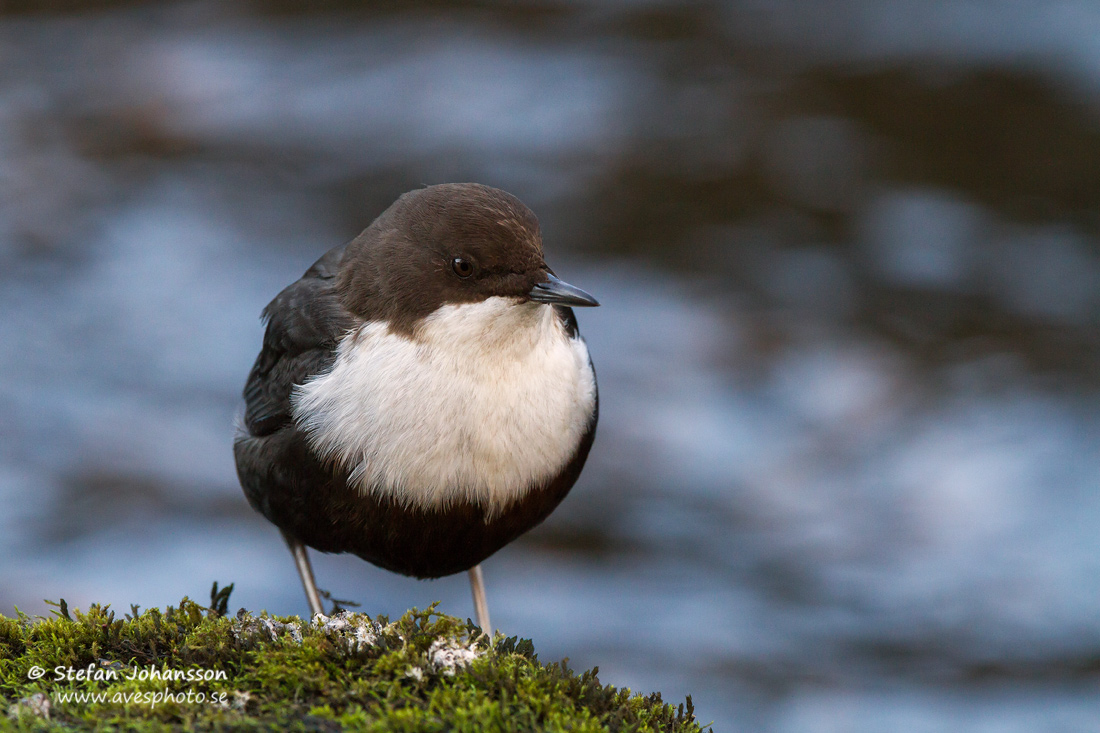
<box><xmin>294</xmin><ymin>297</ymin><xmax>596</xmax><ymax>512</ymax></box>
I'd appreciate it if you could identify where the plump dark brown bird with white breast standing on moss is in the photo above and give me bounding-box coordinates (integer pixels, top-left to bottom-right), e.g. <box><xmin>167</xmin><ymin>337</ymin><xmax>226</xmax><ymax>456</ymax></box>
<box><xmin>227</xmin><ymin>183</ymin><xmax>600</xmax><ymax>633</ymax></box>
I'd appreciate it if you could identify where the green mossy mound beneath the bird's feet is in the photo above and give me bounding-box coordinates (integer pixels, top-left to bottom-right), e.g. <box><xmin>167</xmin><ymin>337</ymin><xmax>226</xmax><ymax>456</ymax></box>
<box><xmin>0</xmin><ymin>587</ymin><xmax>700</xmax><ymax>732</ymax></box>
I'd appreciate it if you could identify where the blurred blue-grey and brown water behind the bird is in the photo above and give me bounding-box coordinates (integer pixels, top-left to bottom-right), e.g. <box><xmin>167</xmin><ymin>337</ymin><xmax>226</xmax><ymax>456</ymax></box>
<box><xmin>0</xmin><ymin>0</ymin><xmax>1100</xmax><ymax>733</ymax></box>
